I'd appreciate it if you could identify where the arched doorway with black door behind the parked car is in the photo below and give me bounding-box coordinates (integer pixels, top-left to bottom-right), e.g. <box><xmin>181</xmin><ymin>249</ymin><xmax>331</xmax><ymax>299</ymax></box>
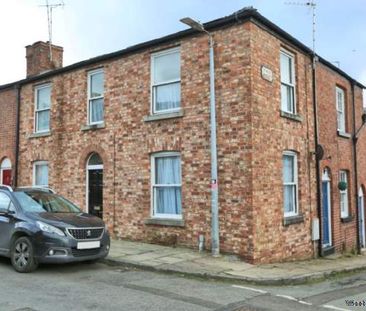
<box><xmin>86</xmin><ymin>153</ymin><xmax>103</xmax><ymax>218</ymax></box>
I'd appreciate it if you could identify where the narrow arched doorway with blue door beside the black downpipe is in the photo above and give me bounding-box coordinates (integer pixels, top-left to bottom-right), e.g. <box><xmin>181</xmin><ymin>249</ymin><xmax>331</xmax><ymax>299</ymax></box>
<box><xmin>321</xmin><ymin>168</ymin><xmax>332</xmax><ymax>248</ymax></box>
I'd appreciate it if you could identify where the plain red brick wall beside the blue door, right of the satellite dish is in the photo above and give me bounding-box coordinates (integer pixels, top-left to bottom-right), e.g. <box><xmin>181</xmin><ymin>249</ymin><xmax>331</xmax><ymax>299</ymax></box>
<box><xmin>316</xmin><ymin>63</ymin><xmax>366</xmax><ymax>252</ymax></box>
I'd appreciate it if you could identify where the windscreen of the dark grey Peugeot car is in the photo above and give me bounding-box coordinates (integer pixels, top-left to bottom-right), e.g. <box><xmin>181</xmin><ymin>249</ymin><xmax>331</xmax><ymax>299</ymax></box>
<box><xmin>13</xmin><ymin>191</ymin><xmax>81</xmax><ymax>213</ymax></box>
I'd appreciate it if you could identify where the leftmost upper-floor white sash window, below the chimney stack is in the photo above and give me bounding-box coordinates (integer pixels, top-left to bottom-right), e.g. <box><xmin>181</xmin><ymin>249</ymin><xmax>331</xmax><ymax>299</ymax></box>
<box><xmin>34</xmin><ymin>84</ymin><xmax>51</xmax><ymax>133</ymax></box>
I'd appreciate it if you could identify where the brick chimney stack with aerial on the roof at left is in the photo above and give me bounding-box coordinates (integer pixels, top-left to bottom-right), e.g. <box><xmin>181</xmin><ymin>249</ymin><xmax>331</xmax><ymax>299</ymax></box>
<box><xmin>25</xmin><ymin>41</ymin><xmax>64</xmax><ymax>78</ymax></box>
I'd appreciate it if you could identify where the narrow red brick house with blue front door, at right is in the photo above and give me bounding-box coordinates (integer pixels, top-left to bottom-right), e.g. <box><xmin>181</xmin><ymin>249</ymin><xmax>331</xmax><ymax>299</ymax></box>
<box><xmin>316</xmin><ymin>63</ymin><xmax>366</xmax><ymax>252</ymax></box>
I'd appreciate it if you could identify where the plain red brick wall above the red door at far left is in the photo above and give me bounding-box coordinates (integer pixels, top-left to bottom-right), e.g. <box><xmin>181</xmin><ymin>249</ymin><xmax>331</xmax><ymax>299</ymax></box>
<box><xmin>0</xmin><ymin>89</ymin><xmax>16</xmax><ymax>183</ymax></box>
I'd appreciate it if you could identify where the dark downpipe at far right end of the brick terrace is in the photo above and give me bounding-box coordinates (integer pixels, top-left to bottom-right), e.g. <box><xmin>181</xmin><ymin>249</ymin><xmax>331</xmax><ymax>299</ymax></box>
<box><xmin>352</xmin><ymin>82</ymin><xmax>364</xmax><ymax>254</ymax></box>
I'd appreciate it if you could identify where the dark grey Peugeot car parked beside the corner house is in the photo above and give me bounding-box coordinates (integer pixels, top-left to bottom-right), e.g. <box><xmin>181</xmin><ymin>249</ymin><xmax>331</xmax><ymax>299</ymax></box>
<box><xmin>0</xmin><ymin>185</ymin><xmax>110</xmax><ymax>272</ymax></box>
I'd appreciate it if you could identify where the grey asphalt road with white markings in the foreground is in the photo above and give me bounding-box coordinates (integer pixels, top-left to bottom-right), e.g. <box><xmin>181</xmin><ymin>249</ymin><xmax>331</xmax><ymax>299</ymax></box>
<box><xmin>0</xmin><ymin>259</ymin><xmax>366</xmax><ymax>311</ymax></box>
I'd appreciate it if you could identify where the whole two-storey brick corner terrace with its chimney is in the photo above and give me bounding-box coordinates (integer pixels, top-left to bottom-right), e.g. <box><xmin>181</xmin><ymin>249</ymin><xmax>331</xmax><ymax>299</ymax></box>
<box><xmin>0</xmin><ymin>9</ymin><xmax>366</xmax><ymax>263</ymax></box>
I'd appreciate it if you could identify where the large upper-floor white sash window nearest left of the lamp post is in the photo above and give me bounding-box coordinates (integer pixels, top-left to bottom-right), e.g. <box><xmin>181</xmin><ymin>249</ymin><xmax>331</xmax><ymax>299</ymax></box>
<box><xmin>151</xmin><ymin>48</ymin><xmax>181</xmax><ymax>114</ymax></box>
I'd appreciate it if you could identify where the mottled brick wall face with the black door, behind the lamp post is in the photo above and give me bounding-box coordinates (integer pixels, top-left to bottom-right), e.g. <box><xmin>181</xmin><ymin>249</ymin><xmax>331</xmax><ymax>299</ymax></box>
<box><xmin>19</xmin><ymin>24</ymin><xmax>253</xmax><ymax>260</ymax></box>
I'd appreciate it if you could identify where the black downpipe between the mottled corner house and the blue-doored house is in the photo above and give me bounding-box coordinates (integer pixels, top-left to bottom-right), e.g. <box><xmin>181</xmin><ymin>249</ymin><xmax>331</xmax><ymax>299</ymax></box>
<box><xmin>312</xmin><ymin>53</ymin><xmax>323</xmax><ymax>256</ymax></box>
